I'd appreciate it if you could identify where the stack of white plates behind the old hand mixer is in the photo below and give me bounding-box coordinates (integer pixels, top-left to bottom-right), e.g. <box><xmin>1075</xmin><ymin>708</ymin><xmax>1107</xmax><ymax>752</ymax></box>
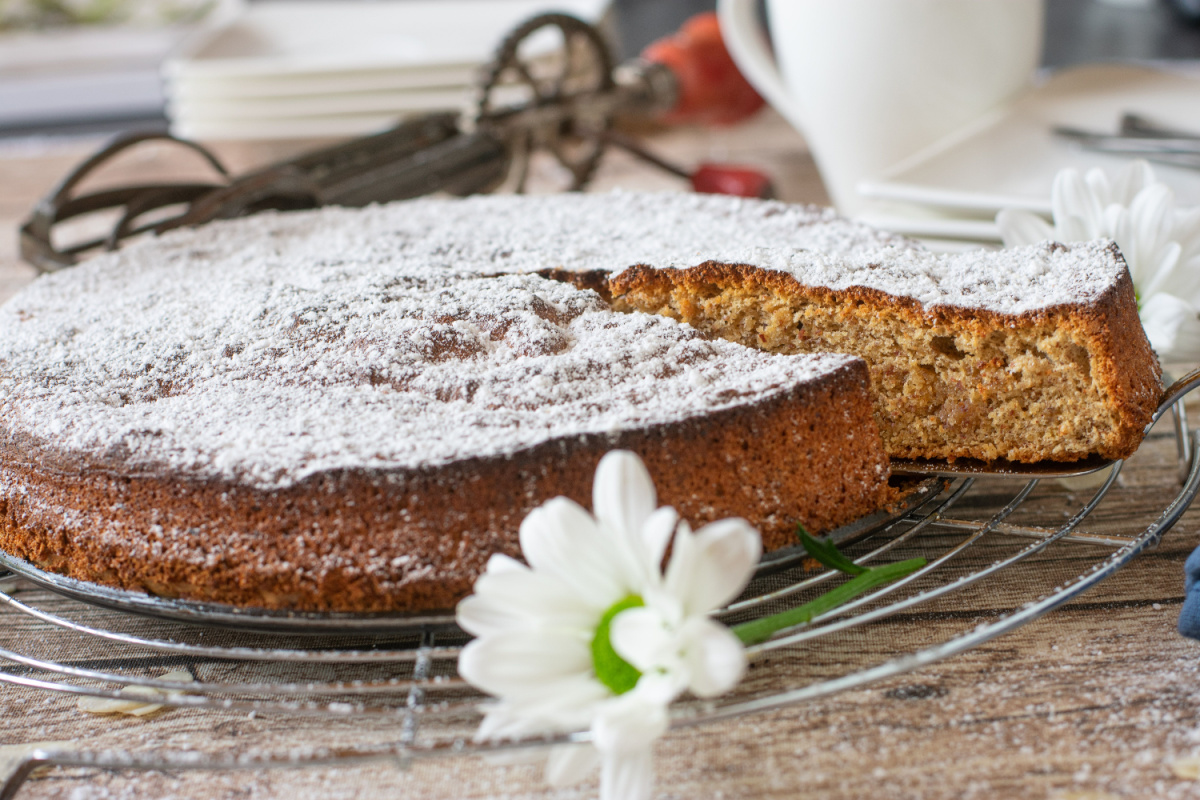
<box><xmin>163</xmin><ymin>0</ymin><xmax>608</xmax><ymax>139</ymax></box>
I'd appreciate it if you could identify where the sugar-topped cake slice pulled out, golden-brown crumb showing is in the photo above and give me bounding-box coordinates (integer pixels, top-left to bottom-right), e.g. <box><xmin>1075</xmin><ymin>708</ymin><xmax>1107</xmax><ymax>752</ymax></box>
<box><xmin>610</xmin><ymin>242</ymin><xmax>1162</xmax><ymax>463</ymax></box>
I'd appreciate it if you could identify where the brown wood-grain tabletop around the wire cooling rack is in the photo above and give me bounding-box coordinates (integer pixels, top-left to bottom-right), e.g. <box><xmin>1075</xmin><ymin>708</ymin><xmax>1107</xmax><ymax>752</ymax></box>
<box><xmin>0</xmin><ymin>114</ymin><xmax>1200</xmax><ymax>800</ymax></box>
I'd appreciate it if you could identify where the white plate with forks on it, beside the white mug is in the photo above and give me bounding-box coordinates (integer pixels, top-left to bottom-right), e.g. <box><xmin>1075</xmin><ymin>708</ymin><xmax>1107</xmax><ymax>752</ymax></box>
<box><xmin>859</xmin><ymin>64</ymin><xmax>1200</xmax><ymax>217</ymax></box>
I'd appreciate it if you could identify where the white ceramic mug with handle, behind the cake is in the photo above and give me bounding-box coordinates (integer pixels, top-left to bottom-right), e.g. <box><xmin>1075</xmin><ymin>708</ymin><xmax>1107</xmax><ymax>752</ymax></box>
<box><xmin>718</xmin><ymin>0</ymin><xmax>1043</xmax><ymax>213</ymax></box>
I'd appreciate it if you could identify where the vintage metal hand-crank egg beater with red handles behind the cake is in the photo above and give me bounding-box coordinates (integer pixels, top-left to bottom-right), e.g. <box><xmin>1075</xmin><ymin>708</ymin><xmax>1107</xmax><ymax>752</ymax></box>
<box><xmin>20</xmin><ymin>13</ymin><xmax>769</xmax><ymax>272</ymax></box>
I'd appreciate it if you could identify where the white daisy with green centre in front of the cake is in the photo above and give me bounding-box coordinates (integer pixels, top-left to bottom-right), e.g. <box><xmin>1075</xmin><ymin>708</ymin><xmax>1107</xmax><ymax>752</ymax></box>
<box><xmin>457</xmin><ymin>451</ymin><xmax>762</xmax><ymax>800</ymax></box>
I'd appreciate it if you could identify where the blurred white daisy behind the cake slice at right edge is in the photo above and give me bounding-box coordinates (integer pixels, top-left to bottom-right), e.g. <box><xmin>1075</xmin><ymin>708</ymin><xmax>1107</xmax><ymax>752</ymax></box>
<box><xmin>996</xmin><ymin>161</ymin><xmax>1200</xmax><ymax>366</ymax></box>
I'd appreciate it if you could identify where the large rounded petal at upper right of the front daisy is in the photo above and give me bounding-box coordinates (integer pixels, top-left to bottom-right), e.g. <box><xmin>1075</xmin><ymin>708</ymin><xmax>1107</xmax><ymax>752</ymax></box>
<box><xmin>666</xmin><ymin>518</ymin><xmax>762</xmax><ymax>614</ymax></box>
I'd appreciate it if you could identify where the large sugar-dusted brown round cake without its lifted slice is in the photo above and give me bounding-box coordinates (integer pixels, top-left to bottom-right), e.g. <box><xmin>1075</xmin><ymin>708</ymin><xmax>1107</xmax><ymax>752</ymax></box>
<box><xmin>0</xmin><ymin>196</ymin><xmax>902</xmax><ymax>610</ymax></box>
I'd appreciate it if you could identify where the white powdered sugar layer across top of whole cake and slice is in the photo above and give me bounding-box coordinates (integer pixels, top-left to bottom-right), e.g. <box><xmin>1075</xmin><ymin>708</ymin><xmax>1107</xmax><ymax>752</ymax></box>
<box><xmin>0</xmin><ymin>193</ymin><xmax>1124</xmax><ymax>487</ymax></box>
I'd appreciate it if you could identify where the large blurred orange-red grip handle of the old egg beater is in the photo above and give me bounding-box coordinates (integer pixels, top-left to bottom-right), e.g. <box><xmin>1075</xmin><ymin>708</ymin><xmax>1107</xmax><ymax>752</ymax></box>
<box><xmin>642</xmin><ymin>12</ymin><xmax>763</xmax><ymax>125</ymax></box>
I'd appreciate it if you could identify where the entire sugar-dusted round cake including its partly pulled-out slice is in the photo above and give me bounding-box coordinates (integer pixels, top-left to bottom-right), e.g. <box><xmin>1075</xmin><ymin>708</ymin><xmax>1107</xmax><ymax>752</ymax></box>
<box><xmin>0</xmin><ymin>194</ymin><xmax>1157</xmax><ymax>610</ymax></box>
